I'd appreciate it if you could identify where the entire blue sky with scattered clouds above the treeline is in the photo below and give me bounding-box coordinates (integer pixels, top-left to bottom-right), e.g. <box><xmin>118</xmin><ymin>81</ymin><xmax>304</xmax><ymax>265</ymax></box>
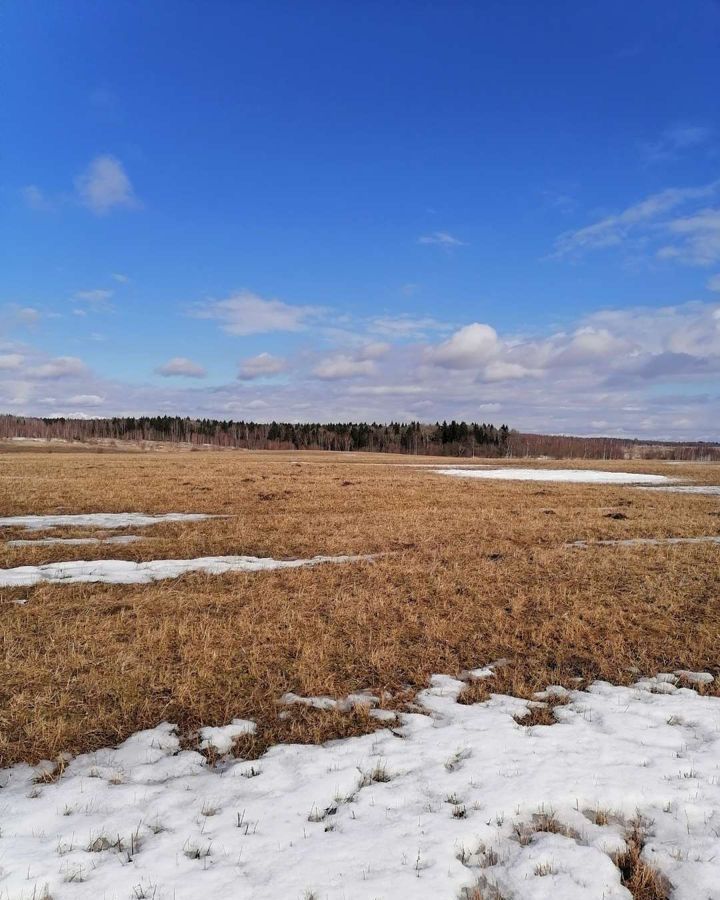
<box><xmin>0</xmin><ymin>0</ymin><xmax>720</xmax><ymax>438</ymax></box>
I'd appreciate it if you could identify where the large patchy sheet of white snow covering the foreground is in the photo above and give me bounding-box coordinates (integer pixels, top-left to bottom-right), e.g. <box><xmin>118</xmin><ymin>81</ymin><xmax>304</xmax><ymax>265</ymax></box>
<box><xmin>0</xmin><ymin>670</ymin><xmax>720</xmax><ymax>900</ymax></box>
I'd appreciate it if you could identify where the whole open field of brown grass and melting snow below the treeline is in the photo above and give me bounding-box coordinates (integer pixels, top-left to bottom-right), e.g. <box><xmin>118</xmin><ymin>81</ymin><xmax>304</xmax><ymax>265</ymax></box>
<box><xmin>0</xmin><ymin>449</ymin><xmax>720</xmax><ymax>900</ymax></box>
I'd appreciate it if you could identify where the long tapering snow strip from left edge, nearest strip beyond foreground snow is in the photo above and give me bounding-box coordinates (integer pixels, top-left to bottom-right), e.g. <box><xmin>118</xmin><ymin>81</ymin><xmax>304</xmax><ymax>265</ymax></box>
<box><xmin>0</xmin><ymin>555</ymin><xmax>375</xmax><ymax>588</ymax></box>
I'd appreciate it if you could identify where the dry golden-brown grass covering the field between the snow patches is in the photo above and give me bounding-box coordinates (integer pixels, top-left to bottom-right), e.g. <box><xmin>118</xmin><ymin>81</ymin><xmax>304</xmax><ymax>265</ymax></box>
<box><xmin>0</xmin><ymin>452</ymin><xmax>720</xmax><ymax>764</ymax></box>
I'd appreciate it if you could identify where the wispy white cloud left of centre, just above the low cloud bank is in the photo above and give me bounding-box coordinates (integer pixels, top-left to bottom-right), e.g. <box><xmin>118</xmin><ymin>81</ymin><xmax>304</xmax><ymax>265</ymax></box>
<box><xmin>192</xmin><ymin>291</ymin><xmax>322</xmax><ymax>335</ymax></box>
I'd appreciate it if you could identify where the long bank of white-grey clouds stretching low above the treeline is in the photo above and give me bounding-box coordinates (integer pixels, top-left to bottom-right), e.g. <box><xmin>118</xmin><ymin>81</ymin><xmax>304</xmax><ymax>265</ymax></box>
<box><xmin>0</xmin><ymin>302</ymin><xmax>720</xmax><ymax>440</ymax></box>
